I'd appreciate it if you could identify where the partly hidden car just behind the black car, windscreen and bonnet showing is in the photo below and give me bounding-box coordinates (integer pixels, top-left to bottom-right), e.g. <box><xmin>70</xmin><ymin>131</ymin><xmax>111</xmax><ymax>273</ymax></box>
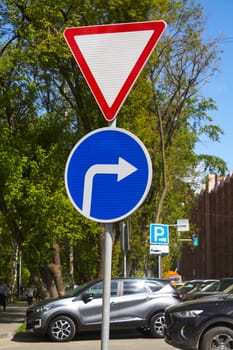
<box><xmin>182</xmin><ymin>277</ymin><xmax>233</xmax><ymax>301</ymax></box>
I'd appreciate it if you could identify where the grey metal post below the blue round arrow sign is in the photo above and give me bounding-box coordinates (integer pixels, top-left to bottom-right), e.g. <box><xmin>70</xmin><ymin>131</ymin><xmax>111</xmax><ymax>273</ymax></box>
<box><xmin>101</xmin><ymin>224</ymin><xmax>112</xmax><ymax>350</ymax></box>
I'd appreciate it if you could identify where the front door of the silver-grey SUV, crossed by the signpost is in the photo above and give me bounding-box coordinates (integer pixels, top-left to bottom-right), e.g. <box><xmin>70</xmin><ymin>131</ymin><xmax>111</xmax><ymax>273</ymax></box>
<box><xmin>80</xmin><ymin>280</ymin><xmax>118</xmax><ymax>328</ymax></box>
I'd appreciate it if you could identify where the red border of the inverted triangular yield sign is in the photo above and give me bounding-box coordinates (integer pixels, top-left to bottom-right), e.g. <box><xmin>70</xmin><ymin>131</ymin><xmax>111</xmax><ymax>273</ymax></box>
<box><xmin>64</xmin><ymin>20</ymin><xmax>166</xmax><ymax>121</ymax></box>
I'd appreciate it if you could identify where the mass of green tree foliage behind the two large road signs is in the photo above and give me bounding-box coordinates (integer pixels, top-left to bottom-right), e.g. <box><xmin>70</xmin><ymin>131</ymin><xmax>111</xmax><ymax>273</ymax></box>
<box><xmin>0</xmin><ymin>0</ymin><xmax>227</xmax><ymax>295</ymax></box>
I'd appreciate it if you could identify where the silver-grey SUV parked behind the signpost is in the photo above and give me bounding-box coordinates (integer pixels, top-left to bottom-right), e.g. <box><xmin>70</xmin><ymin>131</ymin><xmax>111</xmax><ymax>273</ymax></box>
<box><xmin>26</xmin><ymin>278</ymin><xmax>180</xmax><ymax>342</ymax></box>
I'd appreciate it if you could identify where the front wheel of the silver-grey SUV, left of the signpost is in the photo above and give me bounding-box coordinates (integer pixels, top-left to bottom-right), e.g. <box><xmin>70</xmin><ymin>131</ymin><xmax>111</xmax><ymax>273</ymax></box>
<box><xmin>48</xmin><ymin>316</ymin><xmax>76</xmax><ymax>342</ymax></box>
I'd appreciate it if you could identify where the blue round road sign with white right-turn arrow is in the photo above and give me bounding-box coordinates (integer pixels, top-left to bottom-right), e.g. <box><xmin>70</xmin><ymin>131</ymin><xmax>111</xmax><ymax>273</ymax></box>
<box><xmin>65</xmin><ymin>127</ymin><xmax>152</xmax><ymax>223</ymax></box>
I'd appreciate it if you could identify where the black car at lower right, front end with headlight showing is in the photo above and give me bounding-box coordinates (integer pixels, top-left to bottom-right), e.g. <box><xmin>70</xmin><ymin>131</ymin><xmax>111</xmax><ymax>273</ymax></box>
<box><xmin>165</xmin><ymin>294</ymin><xmax>233</xmax><ymax>350</ymax></box>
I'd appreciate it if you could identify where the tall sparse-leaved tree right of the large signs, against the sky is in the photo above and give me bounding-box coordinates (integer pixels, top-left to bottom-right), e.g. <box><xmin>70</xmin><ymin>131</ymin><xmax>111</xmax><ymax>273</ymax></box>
<box><xmin>117</xmin><ymin>1</ymin><xmax>227</xmax><ymax>276</ymax></box>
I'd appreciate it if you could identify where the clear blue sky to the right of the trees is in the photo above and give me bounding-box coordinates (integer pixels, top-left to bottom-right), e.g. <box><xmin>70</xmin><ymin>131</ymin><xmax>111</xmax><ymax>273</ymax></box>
<box><xmin>196</xmin><ymin>0</ymin><xmax>233</xmax><ymax>173</ymax></box>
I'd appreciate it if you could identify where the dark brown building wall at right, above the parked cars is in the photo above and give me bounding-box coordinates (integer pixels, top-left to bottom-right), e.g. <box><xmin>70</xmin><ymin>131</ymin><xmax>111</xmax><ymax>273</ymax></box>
<box><xmin>180</xmin><ymin>174</ymin><xmax>233</xmax><ymax>280</ymax></box>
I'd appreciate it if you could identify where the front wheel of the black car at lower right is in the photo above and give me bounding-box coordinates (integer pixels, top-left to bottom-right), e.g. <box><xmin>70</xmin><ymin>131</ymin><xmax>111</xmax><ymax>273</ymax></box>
<box><xmin>200</xmin><ymin>327</ymin><xmax>233</xmax><ymax>350</ymax></box>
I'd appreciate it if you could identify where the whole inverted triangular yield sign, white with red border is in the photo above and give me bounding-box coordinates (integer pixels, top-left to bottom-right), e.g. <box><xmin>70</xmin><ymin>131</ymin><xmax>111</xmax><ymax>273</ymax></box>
<box><xmin>64</xmin><ymin>21</ymin><xmax>166</xmax><ymax>121</ymax></box>
